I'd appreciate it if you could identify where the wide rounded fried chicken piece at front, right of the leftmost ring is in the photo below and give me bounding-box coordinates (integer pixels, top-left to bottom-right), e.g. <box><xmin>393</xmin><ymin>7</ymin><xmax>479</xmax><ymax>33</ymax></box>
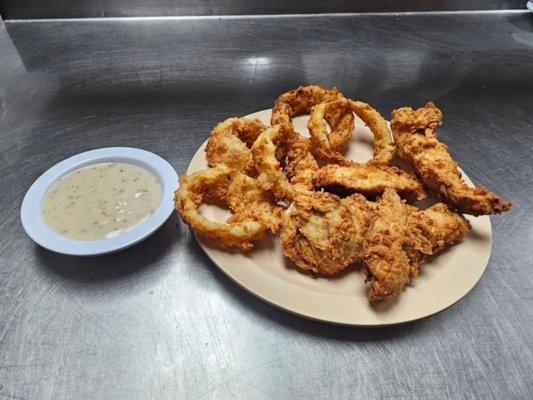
<box><xmin>281</xmin><ymin>192</ymin><xmax>373</xmax><ymax>275</ymax></box>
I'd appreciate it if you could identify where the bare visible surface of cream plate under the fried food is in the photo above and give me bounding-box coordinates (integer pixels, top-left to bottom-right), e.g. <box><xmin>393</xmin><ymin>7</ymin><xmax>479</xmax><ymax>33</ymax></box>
<box><xmin>187</xmin><ymin>110</ymin><xmax>492</xmax><ymax>326</ymax></box>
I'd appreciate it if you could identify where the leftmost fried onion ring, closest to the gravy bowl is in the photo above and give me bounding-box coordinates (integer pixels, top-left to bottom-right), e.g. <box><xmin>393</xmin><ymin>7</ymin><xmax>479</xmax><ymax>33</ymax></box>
<box><xmin>174</xmin><ymin>165</ymin><xmax>283</xmax><ymax>251</ymax></box>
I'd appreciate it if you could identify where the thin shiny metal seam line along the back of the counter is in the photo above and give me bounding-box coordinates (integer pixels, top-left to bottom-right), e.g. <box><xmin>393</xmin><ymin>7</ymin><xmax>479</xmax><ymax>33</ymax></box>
<box><xmin>4</xmin><ymin>9</ymin><xmax>530</xmax><ymax>23</ymax></box>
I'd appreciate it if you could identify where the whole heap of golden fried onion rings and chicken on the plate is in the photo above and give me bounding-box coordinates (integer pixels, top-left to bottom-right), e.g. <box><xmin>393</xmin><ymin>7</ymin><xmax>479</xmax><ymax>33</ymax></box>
<box><xmin>174</xmin><ymin>85</ymin><xmax>511</xmax><ymax>302</ymax></box>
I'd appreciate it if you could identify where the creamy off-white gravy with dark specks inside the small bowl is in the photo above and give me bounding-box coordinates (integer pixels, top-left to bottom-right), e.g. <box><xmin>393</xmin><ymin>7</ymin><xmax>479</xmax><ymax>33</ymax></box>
<box><xmin>43</xmin><ymin>163</ymin><xmax>162</xmax><ymax>240</ymax></box>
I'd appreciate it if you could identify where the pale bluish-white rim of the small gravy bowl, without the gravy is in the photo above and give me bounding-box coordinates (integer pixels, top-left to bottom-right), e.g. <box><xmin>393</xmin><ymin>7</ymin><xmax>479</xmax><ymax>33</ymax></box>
<box><xmin>20</xmin><ymin>147</ymin><xmax>179</xmax><ymax>256</ymax></box>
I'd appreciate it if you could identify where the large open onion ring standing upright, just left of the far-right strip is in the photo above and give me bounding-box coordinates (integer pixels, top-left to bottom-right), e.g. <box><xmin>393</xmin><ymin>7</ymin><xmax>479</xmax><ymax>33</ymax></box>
<box><xmin>307</xmin><ymin>98</ymin><xmax>396</xmax><ymax>165</ymax></box>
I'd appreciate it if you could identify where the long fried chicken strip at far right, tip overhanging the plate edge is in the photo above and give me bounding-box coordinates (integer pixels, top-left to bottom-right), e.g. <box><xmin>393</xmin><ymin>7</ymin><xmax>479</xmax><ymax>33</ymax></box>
<box><xmin>391</xmin><ymin>103</ymin><xmax>511</xmax><ymax>215</ymax></box>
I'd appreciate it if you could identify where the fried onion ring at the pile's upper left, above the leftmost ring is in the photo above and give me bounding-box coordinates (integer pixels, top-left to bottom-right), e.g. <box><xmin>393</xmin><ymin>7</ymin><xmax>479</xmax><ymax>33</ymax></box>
<box><xmin>205</xmin><ymin>118</ymin><xmax>266</xmax><ymax>176</ymax></box>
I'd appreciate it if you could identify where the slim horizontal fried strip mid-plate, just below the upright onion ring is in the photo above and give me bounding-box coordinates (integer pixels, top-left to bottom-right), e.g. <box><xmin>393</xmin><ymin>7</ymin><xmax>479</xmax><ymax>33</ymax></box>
<box><xmin>316</xmin><ymin>163</ymin><xmax>427</xmax><ymax>200</ymax></box>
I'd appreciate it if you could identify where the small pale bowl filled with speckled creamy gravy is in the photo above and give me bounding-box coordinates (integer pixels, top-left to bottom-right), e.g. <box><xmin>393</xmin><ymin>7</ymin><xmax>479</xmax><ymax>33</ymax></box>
<box><xmin>20</xmin><ymin>147</ymin><xmax>178</xmax><ymax>256</ymax></box>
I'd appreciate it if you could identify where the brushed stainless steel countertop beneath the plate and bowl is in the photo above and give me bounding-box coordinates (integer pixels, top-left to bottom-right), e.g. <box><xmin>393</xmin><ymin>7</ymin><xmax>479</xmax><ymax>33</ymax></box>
<box><xmin>0</xmin><ymin>13</ymin><xmax>533</xmax><ymax>400</ymax></box>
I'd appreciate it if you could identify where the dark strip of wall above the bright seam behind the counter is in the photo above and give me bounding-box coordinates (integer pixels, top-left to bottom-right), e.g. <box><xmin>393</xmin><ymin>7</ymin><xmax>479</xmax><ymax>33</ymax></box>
<box><xmin>0</xmin><ymin>0</ymin><xmax>526</xmax><ymax>19</ymax></box>
